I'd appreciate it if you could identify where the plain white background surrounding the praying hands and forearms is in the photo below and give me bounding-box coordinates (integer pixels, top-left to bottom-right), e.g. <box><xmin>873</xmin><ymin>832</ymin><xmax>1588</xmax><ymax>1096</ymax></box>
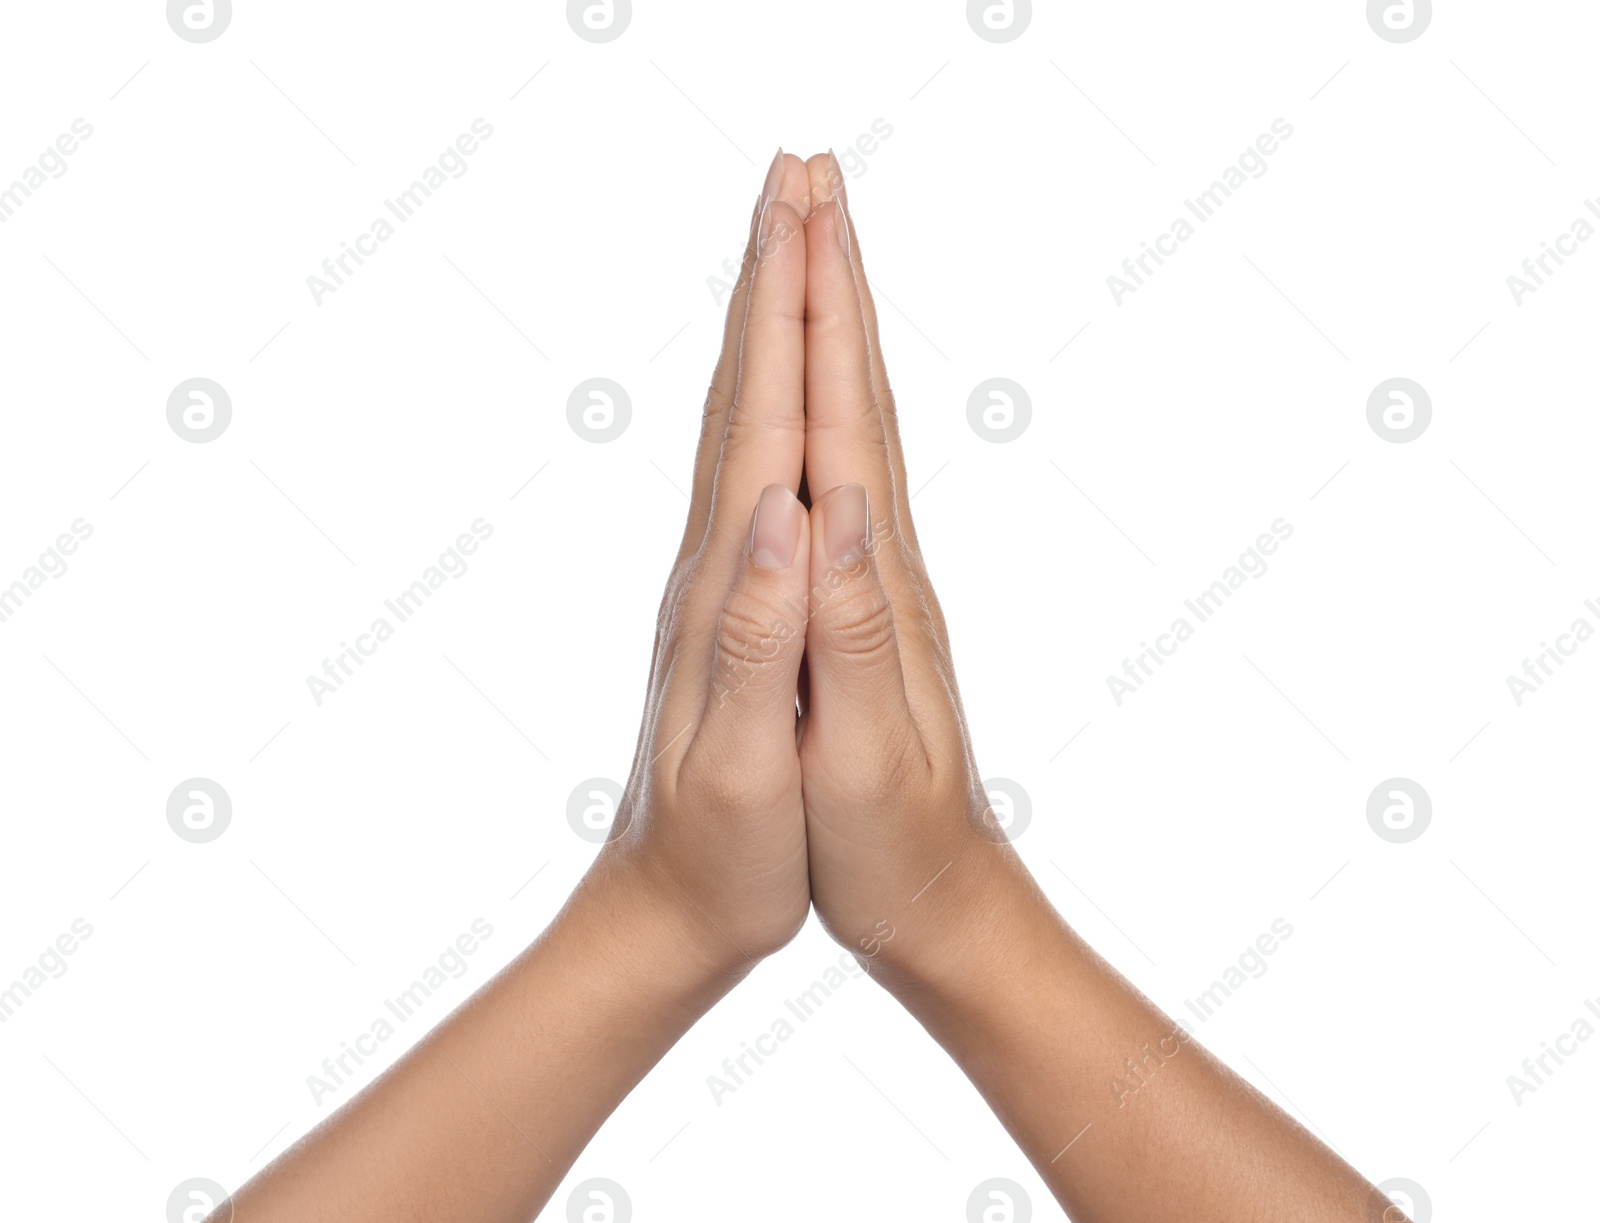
<box><xmin>0</xmin><ymin>0</ymin><xmax>1600</xmax><ymax>1223</ymax></box>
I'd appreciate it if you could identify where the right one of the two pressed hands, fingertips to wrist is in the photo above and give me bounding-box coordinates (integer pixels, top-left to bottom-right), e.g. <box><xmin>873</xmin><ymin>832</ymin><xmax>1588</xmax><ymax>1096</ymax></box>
<box><xmin>800</xmin><ymin>155</ymin><xmax>1037</xmax><ymax>983</ymax></box>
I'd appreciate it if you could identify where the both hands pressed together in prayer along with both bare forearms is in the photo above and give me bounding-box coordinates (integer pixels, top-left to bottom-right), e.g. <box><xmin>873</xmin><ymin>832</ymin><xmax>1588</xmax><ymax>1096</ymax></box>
<box><xmin>214</xmin><ymin>154</ymin><xmax>1403</xmax><ymax>1223</ymax></box>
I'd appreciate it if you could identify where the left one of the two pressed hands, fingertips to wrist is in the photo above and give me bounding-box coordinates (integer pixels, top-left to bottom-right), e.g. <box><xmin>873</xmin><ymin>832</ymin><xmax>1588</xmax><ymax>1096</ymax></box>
<box><xmin>595</xmin><ymin>154</ymin><xmax>811</xmax><ymax>973</ymax></box>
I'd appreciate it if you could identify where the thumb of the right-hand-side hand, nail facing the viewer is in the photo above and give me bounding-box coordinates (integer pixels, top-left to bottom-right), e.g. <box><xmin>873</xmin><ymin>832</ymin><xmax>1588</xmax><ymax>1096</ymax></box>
<box><xmin>805</xmin><ymin>483</ymin><xmax>926</xmax><ymax>767</ymax></box>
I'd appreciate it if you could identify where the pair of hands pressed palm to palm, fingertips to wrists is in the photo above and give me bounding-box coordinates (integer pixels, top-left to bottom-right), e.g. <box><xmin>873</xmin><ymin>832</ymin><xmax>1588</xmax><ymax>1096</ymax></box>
<box><xmin>598</xmin><ymin>152</ymin><xmax>1021</xmax><ymax>992</ymax></box>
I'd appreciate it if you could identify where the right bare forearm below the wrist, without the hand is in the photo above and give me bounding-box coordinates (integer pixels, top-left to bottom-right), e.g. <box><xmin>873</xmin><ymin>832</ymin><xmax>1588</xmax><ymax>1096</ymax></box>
<box><xmin>886</xmin><ymin>850</ymin><xmax>1398</xmax><ymax>1223</ymax></box>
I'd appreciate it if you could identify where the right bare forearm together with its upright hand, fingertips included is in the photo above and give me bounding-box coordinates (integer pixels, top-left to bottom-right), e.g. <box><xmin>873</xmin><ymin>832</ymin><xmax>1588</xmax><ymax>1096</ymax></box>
<box><xmin>800</xmin><ymin>157</ymin><xmax>1402</xmax><ymax>1223</ymax></box>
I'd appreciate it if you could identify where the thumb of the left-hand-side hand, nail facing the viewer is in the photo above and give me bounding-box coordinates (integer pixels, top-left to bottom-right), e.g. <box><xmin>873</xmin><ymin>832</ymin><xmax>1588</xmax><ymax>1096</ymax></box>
<box><xmin>690</xmin><ymin>483</ymin><xmax>811</xmax><ymax>775</ymax></box>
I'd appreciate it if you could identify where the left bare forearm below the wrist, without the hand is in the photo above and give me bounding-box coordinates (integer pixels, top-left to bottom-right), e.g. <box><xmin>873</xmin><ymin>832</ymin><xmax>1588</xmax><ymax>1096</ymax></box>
<box><xmin>234</xmin><ymin>855</ymin><xmax>734</xmax><ymax>1223</ymax></box>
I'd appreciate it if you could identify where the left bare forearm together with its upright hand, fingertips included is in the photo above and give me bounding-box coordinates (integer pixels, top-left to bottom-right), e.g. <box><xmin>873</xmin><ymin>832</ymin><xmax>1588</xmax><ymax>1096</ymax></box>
<box><xmin>213</xmin><ymin>155</ymin><xmax>811</xmax><ymax>1223</ymax></box>
